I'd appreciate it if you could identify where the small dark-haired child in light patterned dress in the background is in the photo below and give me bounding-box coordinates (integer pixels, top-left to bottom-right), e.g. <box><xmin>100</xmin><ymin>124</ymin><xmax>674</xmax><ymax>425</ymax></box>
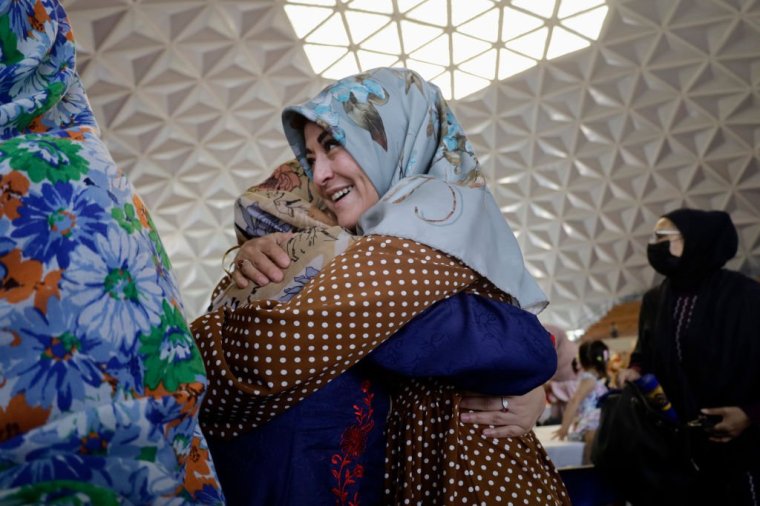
<box><xmin>555</xmin><ymin>341</ymin><xmax>610</xmax><ymax>464</ymax></box>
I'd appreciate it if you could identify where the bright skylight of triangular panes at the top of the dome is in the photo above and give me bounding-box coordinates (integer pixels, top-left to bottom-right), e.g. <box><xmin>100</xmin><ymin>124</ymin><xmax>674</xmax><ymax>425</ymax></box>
<box><xmin>285</xmin><ymin>0</ymin><xmax>608</xmax><ymax>99</ymax></box>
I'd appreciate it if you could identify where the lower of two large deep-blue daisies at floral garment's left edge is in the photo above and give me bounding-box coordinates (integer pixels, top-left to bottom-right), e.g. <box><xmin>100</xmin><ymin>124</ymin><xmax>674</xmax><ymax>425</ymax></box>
<box><xmin>0</xmin><ymin>297</ymin><xmax>104</xmax><ymax>411</ymax></box>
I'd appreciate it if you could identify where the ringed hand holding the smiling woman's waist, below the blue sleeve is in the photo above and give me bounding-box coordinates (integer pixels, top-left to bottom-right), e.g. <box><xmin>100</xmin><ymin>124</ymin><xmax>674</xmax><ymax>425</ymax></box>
<box><xmin>459</xmin><ymin>385</ymin><xmax>546</xmax><ymax>438</ymax></box>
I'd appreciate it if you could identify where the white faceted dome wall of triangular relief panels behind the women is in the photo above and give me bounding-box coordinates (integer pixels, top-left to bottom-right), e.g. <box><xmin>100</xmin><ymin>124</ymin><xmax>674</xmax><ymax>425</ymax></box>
<box><xmin>66</xmin><ymin>0</ymin><xmax>760</xmax><ymax>329</ymax></box>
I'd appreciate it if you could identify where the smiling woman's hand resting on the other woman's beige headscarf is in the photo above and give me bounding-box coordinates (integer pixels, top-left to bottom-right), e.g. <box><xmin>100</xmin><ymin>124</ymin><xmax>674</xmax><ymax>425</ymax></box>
<box><xmin>232</xmin><ymin>232</ymin><xmax>294</xmax><ymax>288</ymax></box>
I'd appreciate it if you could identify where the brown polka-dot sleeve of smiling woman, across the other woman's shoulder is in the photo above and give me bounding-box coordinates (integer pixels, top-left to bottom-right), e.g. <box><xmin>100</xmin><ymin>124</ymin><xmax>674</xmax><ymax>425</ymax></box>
<box><xmin>191</xmin><ymin>236</ymin><xmax>480</xmax><ymax>437</ymax></box>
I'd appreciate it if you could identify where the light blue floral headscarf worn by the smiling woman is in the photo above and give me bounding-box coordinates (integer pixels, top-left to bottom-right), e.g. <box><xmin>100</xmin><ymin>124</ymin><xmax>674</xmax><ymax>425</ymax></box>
<box><xmin>282</xmin><ymin>68</ymin><xmax>547</xmax><ymax>312</ymax></box>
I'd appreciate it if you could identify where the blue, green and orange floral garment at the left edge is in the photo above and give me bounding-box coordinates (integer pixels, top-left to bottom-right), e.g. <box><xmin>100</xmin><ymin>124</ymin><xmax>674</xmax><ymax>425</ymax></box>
<box><xmin>0</xmin><ymin>0</ymin><xmax>223</xmax><ymax>504</ymax></box>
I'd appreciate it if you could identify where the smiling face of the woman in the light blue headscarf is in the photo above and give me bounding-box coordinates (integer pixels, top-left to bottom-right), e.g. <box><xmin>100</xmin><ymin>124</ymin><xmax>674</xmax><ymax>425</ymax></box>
<box><xmin>303</xmin><ymin>122</ymin><xmax>379</xmax><ymax>229</ymax></box>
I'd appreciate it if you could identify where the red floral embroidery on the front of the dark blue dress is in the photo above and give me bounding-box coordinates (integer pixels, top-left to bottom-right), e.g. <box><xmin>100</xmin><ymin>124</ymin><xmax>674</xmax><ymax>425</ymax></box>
<box><xmin>332</xmin><ymin>381</ymin><xmax>375</xmax><ymax>506</ymax></box>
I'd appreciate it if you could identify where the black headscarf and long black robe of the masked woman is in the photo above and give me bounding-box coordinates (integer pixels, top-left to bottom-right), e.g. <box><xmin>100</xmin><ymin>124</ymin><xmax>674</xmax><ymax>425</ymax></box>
<box><xmin>631</xmin><ymin>209</ymin><xmax>760</xmax><ymax>504</ymax></box>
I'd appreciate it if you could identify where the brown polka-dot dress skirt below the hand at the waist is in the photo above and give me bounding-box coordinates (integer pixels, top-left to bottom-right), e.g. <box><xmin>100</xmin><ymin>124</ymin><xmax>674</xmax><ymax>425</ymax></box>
<box><xmin>385</xmin><ymin>380</ymin><xmax>570</xmax><ymax>506</ymax></box>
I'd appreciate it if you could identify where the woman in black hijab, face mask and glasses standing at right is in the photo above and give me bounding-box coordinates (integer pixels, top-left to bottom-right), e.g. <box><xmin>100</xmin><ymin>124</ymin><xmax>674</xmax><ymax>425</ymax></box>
<box><xmin>620</xmin><ymin>209</ymin><xmax>760</xmax><ymax>505</ymax></box>
